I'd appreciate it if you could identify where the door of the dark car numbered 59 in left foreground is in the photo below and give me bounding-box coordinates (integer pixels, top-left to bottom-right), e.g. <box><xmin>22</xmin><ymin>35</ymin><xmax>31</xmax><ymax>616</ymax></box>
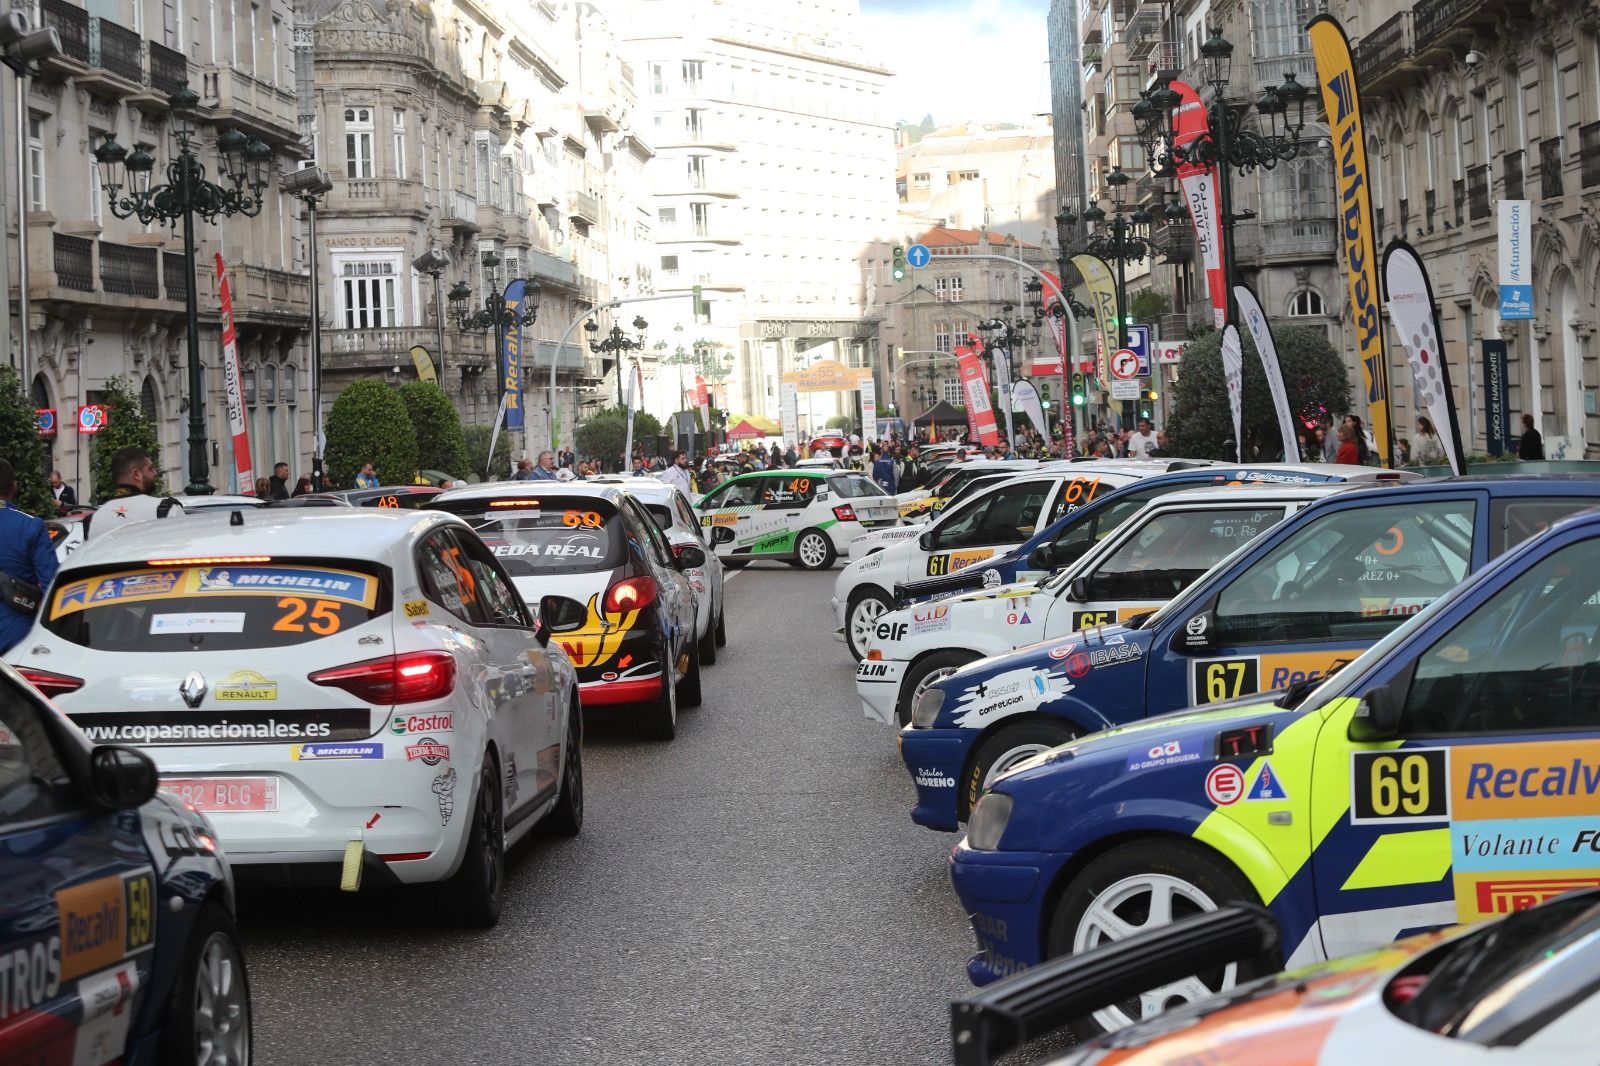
<box><xmin>0</xmin><ymin>677</ymin><xmax>157</xmax><ymax>1063</ymax></box>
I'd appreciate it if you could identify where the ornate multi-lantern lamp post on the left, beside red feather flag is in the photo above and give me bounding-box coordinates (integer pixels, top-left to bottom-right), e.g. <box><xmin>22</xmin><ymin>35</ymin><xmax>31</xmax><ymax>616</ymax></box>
<box><xmin>94</xmin><ymin>83</ymin><xmax>272</xmax><ymax>496</ymax></box>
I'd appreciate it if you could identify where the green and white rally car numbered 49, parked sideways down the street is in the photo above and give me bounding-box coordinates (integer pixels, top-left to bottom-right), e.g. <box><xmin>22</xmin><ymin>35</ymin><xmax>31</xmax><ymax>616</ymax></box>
<box><xmin>694</xmin><ymin>471</ymin><xmax>899</xmax><ymax>570</ymax></box>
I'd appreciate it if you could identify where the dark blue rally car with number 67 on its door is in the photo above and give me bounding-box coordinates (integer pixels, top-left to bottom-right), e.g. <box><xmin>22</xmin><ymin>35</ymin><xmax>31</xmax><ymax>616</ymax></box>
<box><xmin>899</xmin><ymin>475</ymin><xmax>1600</xmax><ymax>831</ymax></box>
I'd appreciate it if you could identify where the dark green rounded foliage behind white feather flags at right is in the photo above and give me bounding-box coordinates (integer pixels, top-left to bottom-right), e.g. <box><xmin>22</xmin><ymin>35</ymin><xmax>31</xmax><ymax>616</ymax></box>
<box><xmin>1166</xmin><ymin>322</ymin><xmax>1350</xmax><ymax>459</ymax></box>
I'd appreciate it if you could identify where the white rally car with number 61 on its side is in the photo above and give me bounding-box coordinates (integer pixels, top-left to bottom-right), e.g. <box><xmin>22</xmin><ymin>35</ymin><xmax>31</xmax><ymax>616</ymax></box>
<box><xmin>834</xmin><ymin>459</ymin><xmax>1170</xmax><ymax>659</ymax></box>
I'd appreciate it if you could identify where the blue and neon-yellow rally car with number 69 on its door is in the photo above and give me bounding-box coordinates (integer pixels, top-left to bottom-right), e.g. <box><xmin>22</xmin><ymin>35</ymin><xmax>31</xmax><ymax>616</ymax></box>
<box><xmin>950</xmin><ymin>502</ymin><xmax>1600</xmax><ymax>1029</ymax></box>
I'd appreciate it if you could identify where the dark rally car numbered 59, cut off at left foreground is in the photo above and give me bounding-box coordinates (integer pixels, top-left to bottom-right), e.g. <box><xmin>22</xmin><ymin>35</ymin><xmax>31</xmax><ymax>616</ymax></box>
<box><xmin>0</xmin><ymin>667</ymin><xmax>251</xmax><ymax>1066</ymax></box>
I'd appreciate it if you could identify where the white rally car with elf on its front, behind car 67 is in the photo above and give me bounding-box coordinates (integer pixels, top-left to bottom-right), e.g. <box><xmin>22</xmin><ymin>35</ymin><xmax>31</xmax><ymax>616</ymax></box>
<box><xmin>856</xmin><ymin>483</ymin><xmax>1349</xmax><ymax>725</ymax></box>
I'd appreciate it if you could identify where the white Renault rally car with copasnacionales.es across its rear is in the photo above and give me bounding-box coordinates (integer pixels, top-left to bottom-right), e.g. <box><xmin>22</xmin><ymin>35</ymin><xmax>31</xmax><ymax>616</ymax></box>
<box><xmin>10</xmin><ymin>507</ymin><xmax>582</xmax><ymax>925</ymax></box>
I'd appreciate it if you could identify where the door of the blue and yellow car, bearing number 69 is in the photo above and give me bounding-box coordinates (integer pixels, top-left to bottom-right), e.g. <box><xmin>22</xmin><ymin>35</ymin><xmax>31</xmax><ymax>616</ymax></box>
<box><xmin>1310</xmin><ymin>528</ymin><xmax>1600</xmax><ymax>957</ymax></box>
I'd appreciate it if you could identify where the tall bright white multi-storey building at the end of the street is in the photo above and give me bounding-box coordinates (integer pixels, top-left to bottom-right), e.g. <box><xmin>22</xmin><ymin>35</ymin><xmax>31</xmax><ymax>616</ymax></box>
<box><xmin>618</xmin><ymin>0</ymin><xmax>894</xmax><ymax>432</ymax></box>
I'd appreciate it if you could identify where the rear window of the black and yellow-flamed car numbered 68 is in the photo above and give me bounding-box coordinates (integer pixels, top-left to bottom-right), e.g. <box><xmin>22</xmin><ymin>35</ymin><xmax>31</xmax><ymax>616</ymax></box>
<box><xmin>440</xmin><ymin>495</ymin><xmax>626</xmax><ymax>578</ymax></box>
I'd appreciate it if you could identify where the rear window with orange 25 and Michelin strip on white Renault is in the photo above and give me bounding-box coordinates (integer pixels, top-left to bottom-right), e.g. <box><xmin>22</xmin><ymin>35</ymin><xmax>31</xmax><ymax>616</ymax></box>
<box><xmin>45</xmin><ymin>559</ymin><xmax>392</xmax><ymax>653</ymax></box>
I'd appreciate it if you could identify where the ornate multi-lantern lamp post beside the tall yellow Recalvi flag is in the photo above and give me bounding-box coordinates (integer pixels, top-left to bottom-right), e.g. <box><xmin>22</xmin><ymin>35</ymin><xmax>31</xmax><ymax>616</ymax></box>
<box><xmin>1133</xmin><ymin>29</ymin><xmax>1307</xmax><ymax>322</ymax></box>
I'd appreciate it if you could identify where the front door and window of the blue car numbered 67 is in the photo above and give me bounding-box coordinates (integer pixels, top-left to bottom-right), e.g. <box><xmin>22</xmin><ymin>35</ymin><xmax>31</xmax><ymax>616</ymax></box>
<box><xmin>1146</xmin><ymin>490</ymin><xmax>1488</xmax><ymax>714</ymax></box>
